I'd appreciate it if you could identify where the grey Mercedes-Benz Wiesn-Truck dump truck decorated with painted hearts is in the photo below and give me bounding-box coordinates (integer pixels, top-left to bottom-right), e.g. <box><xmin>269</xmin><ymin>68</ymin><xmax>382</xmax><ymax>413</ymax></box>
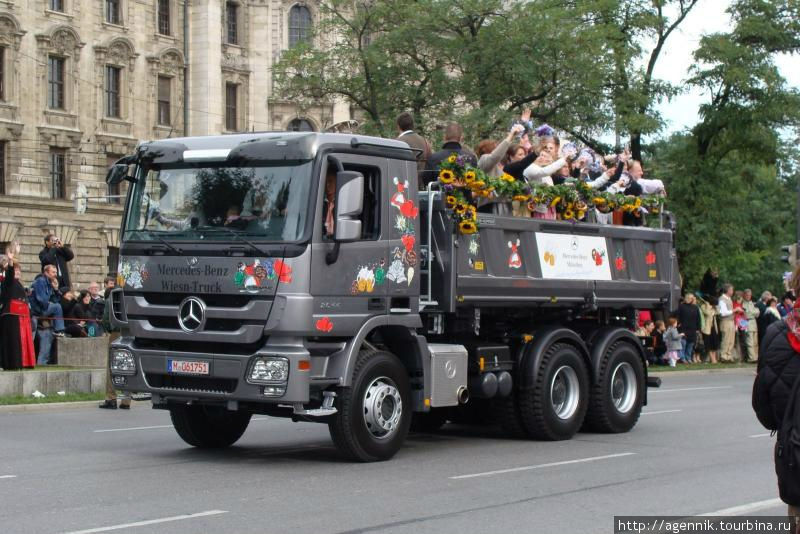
<box><xmin>107</xmin><ymin>133</ymin><xmax>679</xmax><ymax>461</ymax></box>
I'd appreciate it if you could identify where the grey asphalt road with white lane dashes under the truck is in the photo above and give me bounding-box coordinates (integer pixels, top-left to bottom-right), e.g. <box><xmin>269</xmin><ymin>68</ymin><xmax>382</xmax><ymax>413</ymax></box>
<box><xmin>0</xmin><ymin>369</ymin><xmax>785</xmax><ymax>534</ymax></box>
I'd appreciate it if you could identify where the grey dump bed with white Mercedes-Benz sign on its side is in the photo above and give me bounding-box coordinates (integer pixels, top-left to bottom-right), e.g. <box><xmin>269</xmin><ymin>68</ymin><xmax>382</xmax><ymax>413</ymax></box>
<box><xmin>421</xmin><ymin>199</ymin><xmax>680</xmax><ymax>312</ymax></box>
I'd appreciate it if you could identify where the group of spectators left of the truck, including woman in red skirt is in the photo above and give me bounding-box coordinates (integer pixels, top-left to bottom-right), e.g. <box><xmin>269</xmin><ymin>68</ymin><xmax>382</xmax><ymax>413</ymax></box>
<box><xmin>0</xmin><ymin>239</ymin><xmax>115</xmax><ymax>370</ymax></box>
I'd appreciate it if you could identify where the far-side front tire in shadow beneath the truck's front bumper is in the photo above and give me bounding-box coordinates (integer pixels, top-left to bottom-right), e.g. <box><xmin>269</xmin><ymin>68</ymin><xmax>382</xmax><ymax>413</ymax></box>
<box><xmin>169</xmin><ymin>404</ymin><xmax>251</xmax><ymax>449</ymax></box>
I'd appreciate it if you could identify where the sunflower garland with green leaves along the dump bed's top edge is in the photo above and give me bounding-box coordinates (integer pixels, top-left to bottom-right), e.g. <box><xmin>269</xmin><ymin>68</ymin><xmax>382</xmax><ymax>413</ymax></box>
<box><xmin>439</xmin><ymin>153</ymin><xmax>664</xmax><ymax>234</ymax></box>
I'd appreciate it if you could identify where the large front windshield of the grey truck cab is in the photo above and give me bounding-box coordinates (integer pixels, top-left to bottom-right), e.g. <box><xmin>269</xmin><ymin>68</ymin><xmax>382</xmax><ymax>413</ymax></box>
<box><xmin>124</xmin><ymin>162</ymin><xmax>311</xmax><ymax>242</ymax></box>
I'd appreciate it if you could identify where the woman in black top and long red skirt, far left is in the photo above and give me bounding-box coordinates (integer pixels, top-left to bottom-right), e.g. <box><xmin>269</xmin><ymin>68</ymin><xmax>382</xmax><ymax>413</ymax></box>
<box><xmin>0</xmin><ymin>243</ymin><xmax>36</xmax><ymax>370</ymax></box>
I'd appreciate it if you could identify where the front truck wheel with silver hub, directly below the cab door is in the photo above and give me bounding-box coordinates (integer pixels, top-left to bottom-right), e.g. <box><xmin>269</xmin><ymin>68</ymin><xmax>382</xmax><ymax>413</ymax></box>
<box><xmin>328</xmin><ymin>350</ymin><xmax>411</xmax><ymax>462</ymax></box>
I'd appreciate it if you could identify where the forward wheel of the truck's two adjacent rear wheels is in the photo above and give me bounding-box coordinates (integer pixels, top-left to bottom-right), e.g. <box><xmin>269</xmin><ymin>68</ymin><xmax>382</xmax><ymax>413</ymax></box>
<box><xmin>517</xmin><ymin>343</ymin><xmax>589</xmax><ymax>441</ymax></box>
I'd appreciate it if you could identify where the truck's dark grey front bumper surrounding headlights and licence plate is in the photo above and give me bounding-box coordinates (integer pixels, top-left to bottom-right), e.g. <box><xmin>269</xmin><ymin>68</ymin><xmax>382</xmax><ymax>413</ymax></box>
<box><xmin>111</xmin><ymin>337</ymin><xmax>311</xmax><ymax>404</ymax></box>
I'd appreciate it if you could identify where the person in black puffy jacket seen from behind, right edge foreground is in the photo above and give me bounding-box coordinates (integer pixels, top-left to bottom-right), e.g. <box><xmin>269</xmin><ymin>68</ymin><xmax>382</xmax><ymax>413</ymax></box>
<box><xmin>753</xmin><ymin>321</ymin><xmax>800</xmax><ymax>532</ymax></box>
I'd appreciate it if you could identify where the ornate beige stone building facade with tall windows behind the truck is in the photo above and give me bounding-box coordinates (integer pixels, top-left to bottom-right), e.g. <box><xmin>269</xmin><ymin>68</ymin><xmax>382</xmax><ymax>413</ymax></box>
<box><xmin>0</xmin><ymin>0</ymin><xmax>352</xmax><ymax>288</ymax></box>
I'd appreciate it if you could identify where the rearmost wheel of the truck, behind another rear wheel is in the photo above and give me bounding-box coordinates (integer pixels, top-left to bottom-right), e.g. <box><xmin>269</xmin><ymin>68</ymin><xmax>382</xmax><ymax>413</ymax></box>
<box><xmin>584</xmin><ymin>341</ymin><xmax>645</xmax><ymax>434</ymax></box>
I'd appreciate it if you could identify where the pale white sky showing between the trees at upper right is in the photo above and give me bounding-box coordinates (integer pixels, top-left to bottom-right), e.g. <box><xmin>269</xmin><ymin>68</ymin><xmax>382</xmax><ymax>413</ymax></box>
<box><xmin>655</xmin><ymin>0</ymin><xmax>800</xmax><ymax>140</ymax></box>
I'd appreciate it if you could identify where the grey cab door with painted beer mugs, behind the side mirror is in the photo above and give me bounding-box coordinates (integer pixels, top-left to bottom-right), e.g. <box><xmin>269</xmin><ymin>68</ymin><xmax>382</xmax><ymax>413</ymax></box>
<box><xmin>310</xmin><ymin>154</ymin><xmax>391</xmax><ymax>336</ymax></box>
